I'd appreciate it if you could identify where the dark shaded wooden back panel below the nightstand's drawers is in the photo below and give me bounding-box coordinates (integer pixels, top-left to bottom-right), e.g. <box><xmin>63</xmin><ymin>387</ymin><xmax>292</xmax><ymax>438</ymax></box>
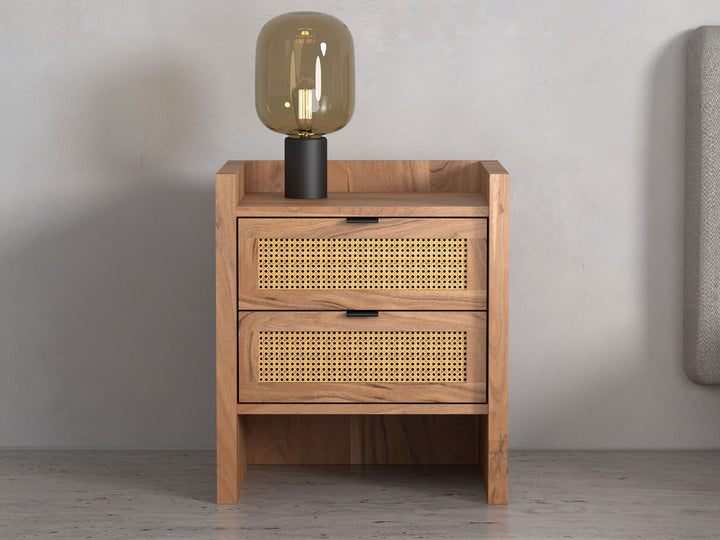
<box><xmin>247</xmin><ymin>415</ymin><xmax>479</xmax><ymax>465</ymax></box>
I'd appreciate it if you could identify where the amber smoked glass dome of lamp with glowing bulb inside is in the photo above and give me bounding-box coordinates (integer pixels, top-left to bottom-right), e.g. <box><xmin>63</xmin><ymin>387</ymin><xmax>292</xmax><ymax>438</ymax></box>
<box><xmin>255</xmin><ymin>11</ymin><xmax>355</xmax><ymax>137</ymax></box>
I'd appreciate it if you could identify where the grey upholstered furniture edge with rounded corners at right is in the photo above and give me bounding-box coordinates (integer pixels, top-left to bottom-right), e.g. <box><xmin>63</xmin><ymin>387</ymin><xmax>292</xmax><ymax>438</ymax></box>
<box><xmin>683</xmin><ymin>26</ymin><xmax>720</xmax><ymax>384</ymax></box>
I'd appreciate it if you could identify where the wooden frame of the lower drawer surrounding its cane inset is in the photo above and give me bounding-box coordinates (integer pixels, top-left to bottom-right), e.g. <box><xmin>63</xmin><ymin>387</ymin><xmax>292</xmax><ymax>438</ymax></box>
<box><xmin>238</xmin><ymin>311</ymin><xmax>486</xmax><ymax>403</ymax></box>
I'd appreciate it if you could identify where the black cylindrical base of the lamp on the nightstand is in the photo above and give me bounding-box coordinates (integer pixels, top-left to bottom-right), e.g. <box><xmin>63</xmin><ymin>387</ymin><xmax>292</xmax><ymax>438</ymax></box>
<box><xmin>285</xmin><ymin>137</ymin><xmax>327</xmax><ymax>199</ymax></box>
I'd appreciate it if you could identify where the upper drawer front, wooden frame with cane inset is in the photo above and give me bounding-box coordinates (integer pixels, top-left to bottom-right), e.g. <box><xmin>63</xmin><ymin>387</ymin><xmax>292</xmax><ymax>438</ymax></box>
<box><xmin>238</xmin><ymin>218</ymin><xmax>487</xmax><ymax>311</ymax></box>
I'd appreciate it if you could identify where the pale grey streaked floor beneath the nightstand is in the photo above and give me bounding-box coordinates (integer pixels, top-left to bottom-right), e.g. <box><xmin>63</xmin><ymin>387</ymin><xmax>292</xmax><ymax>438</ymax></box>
<box><xmin>0</xmin><ymin>450</ymin><xmax>720</xmax><ymax>540</ymax></box>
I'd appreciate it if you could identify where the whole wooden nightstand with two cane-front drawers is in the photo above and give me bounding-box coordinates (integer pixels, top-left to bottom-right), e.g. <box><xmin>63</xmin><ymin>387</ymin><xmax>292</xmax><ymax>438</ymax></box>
<box><xmin>215</xmin><ymin>161</ymin><xmax>509</xmax><ymax>504</ymax></box>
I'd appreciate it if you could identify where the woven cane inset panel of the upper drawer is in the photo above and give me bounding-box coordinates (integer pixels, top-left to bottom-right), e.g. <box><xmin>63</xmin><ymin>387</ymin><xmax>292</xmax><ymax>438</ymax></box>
<box><xmin>258</xmin><ymin>238</ymin><xmax>467</xmax><ymax>290</ymax></box>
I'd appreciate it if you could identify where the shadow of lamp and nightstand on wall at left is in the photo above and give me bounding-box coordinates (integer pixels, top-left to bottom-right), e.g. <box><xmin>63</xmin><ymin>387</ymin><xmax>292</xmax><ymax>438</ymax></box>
<box><xmin>0</xmin><ymin>58</ymin><xmax>215</xmax><ymax>448</ymax></box>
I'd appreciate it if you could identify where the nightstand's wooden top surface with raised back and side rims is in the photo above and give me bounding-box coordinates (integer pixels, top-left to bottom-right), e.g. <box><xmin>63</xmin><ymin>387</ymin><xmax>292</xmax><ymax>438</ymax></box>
<box><xmin>216</xmin><ymin>160</ymin><xmax>508</xmax><ymax>218</ymax></box>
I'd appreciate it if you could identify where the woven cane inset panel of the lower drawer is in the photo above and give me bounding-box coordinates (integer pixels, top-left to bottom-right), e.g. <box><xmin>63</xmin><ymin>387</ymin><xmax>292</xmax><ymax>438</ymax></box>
<box><xmin>258</xmin><ymin>331</ymin><xmax>467</xmax><ymax>383</ymax></box>
